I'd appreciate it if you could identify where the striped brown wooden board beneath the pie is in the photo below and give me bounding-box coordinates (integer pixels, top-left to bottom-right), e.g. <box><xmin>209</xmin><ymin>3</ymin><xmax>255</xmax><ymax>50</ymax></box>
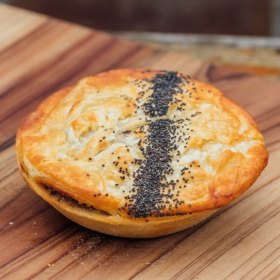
<box><xmin>0</xmin><ymin>5</ymin><xmax>280</xmax><ymax>280</ymax></box>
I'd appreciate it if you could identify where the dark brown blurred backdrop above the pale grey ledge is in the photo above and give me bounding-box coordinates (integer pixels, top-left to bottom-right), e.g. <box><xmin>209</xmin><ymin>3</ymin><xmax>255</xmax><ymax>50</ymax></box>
<box><xmin>2</xmin><ymin>0</ymin><xmax>280</xmax><ymax>36</ymax></box>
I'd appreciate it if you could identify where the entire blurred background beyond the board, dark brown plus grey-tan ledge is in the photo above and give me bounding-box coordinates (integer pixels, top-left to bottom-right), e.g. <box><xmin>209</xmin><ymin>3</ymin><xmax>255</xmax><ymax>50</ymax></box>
<box><xmin>0</xmin><ymin>0</ymin><xmax>280</xmax><ymax>78</ymax></box>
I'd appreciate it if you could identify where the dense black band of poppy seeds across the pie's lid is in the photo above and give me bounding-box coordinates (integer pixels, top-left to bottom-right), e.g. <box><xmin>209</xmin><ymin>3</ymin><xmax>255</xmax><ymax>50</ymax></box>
<box><xmin>128</xmin><ymin>71</ymin><xmax>182</xmax><ymax>218</ymax></box>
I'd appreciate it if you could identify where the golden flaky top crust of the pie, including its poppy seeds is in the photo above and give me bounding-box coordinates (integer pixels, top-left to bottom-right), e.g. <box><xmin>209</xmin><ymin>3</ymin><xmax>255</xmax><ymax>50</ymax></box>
<box><xmin>17</xmin><ymin>69</ymin><xmax>268</xmax><ymax>236</ymax></box>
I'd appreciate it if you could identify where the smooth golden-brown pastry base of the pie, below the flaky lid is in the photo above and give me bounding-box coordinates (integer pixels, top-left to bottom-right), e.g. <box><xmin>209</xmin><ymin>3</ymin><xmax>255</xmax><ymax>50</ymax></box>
<box><xmin>20</xmin><ymin>170</ymin><xmax>217</xmax><ymax>238</ymax></box>
